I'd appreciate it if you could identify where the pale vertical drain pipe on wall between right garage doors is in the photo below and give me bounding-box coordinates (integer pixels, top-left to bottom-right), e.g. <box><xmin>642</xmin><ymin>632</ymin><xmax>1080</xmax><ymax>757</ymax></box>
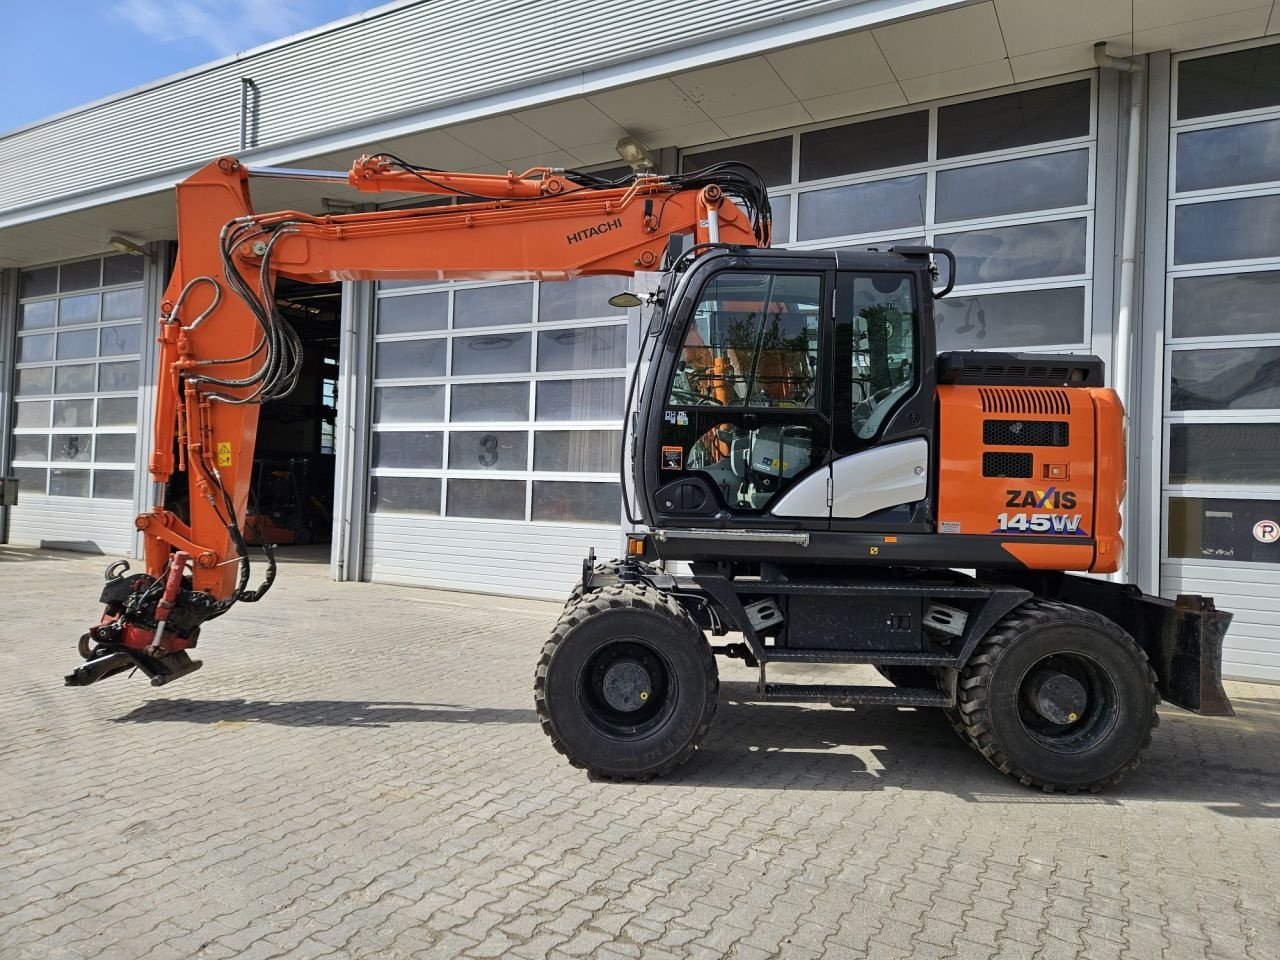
<box><xmin>1093</xmin><ymin>41</ymin><xmax>1143</xmax><ymax>582</ymax></box>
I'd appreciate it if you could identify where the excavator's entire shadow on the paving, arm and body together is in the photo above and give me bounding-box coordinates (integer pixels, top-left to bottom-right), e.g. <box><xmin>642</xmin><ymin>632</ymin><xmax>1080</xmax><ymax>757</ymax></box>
<box><xmin>115</xmin><ymin>682</ymin><xmax>1280</xmax><ymax>819</ymax></box>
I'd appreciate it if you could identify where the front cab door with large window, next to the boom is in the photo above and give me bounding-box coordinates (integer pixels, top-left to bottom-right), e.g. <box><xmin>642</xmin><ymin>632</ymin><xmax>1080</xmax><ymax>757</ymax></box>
<box><xmin>649</xmin><ymin>257</ymin><xmax>835</xmax><ymax>530</ymax></box>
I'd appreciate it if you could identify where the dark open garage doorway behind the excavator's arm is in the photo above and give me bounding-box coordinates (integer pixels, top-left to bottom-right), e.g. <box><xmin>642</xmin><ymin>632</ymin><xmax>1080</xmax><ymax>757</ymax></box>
<box><xmin>244</xmin><ymin>279</ymin><xmax>342</xmax><ymax>563</ymax></box>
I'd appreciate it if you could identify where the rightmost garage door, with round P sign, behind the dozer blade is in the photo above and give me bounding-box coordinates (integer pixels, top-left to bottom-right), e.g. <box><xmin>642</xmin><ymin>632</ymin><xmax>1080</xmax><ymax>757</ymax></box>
<box><xmin>1161</xmin><ymin>46</ymin><xmax>1280</xmax><ymax>681</ymax></box>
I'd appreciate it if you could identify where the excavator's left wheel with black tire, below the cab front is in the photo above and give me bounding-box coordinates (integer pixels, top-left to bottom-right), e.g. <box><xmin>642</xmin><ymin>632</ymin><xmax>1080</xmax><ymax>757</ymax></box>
<box><xmin>534</xmin><ymin>584</ymin><xmax>719</xmax><ymax>781</ymax></box>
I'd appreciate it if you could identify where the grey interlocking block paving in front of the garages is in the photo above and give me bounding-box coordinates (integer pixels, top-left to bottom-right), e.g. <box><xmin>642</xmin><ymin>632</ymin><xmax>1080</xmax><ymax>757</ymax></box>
<box><xmin>0</xmin><ymin>548</ymin><xmax>1280</xmax><ymax>960</ymax></box>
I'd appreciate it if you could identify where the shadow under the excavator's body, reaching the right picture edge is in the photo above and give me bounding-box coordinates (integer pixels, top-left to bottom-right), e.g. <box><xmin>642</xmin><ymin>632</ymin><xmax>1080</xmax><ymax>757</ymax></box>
<box><xmin>663</xmin><ymin>684</ymin><xmax>1280</xmax><ymax>819</ymax></box>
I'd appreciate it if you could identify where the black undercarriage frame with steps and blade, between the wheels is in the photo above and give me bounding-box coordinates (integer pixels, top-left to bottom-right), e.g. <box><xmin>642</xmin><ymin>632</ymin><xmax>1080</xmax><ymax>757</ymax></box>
<box><xmin>582</xmin><ymin>558</ymin><xmax>1233</xmax><ymax>716</ymax></box>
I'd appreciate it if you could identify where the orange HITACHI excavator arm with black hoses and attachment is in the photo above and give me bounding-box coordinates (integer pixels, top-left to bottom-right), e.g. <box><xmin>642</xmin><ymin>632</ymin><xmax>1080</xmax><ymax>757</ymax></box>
<box><xmin>67</xmin><ymin>155</ymin><xmax>771</xmax><ymax>686</ymax></box>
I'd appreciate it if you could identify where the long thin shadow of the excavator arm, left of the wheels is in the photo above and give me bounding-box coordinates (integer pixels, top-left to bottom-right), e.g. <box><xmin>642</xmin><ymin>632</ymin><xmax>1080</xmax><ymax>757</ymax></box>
<box><xmin>114</xmin><ymin>700</ymin><xmax>538</xmax><ymax>727</ymax></box>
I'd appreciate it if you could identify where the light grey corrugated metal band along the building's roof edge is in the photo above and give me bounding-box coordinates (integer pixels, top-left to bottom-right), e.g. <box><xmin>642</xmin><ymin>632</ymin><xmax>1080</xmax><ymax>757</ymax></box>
<box><xmin>0</xmin><ymin>0</ymin><xmax>859</xmax><ymax>210</ymax></box>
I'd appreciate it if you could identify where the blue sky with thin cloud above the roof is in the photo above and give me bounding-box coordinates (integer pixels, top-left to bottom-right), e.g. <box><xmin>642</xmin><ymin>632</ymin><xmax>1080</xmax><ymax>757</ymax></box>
<box><xmin>0</xmin><ymin>0</ymin><xmax>385</xmax><ymax>136</ymax></box>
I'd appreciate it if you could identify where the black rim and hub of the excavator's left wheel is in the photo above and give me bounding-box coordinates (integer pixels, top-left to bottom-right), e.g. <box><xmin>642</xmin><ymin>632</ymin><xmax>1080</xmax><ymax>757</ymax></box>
<box><xmin>577</xmin><ymin>637</ymin><xmax>678</xmax><ymax>740</ymax></box>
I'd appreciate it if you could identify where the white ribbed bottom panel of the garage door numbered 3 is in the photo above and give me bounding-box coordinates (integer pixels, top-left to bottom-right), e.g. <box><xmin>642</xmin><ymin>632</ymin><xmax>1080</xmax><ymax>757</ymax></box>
<box><xmin>364</xmin><ymin>513</ymin><xmax>622</xmax><ymax>600</ymax></box>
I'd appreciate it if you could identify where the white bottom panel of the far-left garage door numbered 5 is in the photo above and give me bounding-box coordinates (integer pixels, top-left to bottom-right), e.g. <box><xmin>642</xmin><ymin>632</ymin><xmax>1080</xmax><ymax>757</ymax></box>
<box><xmin>9</xmin><ymin>490</ymin><xmax>134</xmax><ymax>557</ymax></box>
